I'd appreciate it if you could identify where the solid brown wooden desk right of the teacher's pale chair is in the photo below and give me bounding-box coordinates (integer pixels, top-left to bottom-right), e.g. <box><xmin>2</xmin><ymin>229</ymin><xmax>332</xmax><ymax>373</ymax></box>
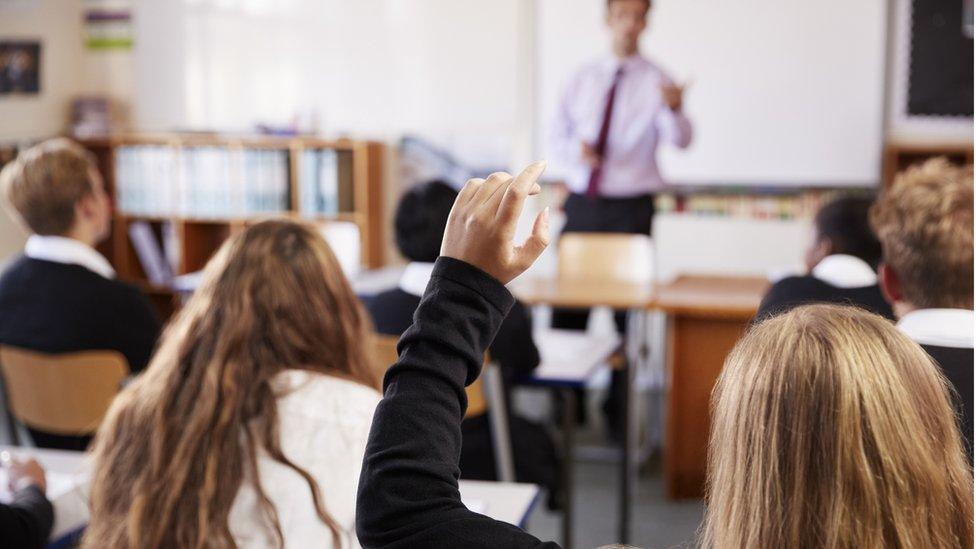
<box><xmin>650</xmin><ymin>276</ymin><xmax>769</xmax><ymax>498</ymax></box>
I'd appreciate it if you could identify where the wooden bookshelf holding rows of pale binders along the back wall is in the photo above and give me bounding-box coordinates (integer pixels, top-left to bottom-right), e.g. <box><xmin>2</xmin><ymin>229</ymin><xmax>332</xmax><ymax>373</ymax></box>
<box><xmin>80</xmin><ymin>134</ymin><xmax>385</xmax><ymax>317</ymax></box>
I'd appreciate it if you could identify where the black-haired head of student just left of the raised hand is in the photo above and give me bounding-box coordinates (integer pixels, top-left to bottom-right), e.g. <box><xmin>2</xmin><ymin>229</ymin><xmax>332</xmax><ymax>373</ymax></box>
<box><xmin>393</xmin><ymin>181</ymin><xmax>457</xmax><ymax>263</ymax></box>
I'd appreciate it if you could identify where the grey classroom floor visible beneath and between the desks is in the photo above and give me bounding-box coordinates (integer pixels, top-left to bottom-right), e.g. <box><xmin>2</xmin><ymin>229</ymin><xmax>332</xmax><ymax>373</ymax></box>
<box><xmin>515</xmin><ymin>391</ymin><xmax>704</xmax><ymax>549</ymax></box>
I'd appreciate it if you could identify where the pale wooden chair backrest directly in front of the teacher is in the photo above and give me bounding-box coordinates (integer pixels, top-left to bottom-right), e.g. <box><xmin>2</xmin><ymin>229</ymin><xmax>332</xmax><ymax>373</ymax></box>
<box><xmin>559</xmin><ymin>233</ymin><xmax>654</xmax><ymax>284</ymax></box>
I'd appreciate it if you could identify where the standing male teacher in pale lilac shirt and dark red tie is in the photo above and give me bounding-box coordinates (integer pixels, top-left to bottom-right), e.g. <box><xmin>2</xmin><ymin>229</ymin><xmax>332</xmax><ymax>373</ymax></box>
<box><xmin>551</xmin><ymin>0</ymin><xmax>692</xmax><ymax>438</ymax></box>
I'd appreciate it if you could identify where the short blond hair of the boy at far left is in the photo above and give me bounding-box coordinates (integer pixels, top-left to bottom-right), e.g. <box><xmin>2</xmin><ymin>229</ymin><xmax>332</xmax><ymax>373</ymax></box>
<box><xmin>0</xmin><ymin>138</ymin><xmax>95</xmax><ymax>235</ymax></box>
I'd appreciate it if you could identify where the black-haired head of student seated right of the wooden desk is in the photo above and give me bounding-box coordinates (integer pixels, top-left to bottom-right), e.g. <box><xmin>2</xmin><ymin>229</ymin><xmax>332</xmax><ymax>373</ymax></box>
<box><xmin>806</xmin><ymin>196</ymin><xmax>881</xmax><ymax>269</ymax></box>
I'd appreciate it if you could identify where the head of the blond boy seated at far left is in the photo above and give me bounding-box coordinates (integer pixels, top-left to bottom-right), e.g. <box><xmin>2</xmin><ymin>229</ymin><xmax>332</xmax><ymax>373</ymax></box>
<box><xmin>0</xmin><ymin>138</ymin><xmax>111</xmax><ymax>245</ymax></box>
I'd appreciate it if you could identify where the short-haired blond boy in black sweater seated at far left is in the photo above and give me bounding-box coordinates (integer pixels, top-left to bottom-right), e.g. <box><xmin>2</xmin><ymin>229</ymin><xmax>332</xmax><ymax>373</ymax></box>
<box><xmin>0</xmin><ymin>139</ymin><xmax>160</xmax><ymax>450</ymax></box>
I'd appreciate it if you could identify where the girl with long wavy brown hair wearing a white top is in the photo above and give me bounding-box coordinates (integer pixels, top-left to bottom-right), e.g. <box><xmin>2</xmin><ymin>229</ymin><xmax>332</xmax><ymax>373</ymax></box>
<box><xmin>83</xmin><ymin>221</ymin><xmax>380</xmax><ymax>548</ymax></box>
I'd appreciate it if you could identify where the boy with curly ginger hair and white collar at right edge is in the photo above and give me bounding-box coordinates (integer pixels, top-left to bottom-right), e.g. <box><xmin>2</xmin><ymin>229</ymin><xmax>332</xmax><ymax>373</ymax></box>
<box><xmin>871</xmin><ymin>159</ymin><xmax>973</xmax><ymax>458</ymax></box>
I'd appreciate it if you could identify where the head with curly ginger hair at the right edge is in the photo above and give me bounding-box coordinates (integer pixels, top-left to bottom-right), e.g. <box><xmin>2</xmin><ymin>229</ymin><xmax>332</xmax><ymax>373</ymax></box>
<box><xmin>871</xmin><ymin>158</ymin><xmax>973</xmax><ymax>316</ymax></box>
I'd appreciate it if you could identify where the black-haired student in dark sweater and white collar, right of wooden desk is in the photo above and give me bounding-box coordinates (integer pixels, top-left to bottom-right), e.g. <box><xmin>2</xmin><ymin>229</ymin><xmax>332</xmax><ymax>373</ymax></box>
<box><xmin>756</xmin><ymin>196</ymin><xmax>894</xmax><ymax>320</ymax></box>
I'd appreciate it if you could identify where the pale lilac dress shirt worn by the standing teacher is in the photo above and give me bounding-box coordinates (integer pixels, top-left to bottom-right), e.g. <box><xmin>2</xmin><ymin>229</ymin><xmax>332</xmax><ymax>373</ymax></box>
<box><xmin>549</xmin><ymin>54</ymin><xmax>692</xmax><ymax>197</ymax></box>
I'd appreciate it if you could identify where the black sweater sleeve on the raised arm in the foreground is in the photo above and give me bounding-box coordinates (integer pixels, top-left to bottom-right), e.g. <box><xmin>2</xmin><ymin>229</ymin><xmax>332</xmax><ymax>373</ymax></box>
<box><xmin>356</xmin><ymin>257</ymin><xmax>558</xmax><ymax>549</ymax></box>
